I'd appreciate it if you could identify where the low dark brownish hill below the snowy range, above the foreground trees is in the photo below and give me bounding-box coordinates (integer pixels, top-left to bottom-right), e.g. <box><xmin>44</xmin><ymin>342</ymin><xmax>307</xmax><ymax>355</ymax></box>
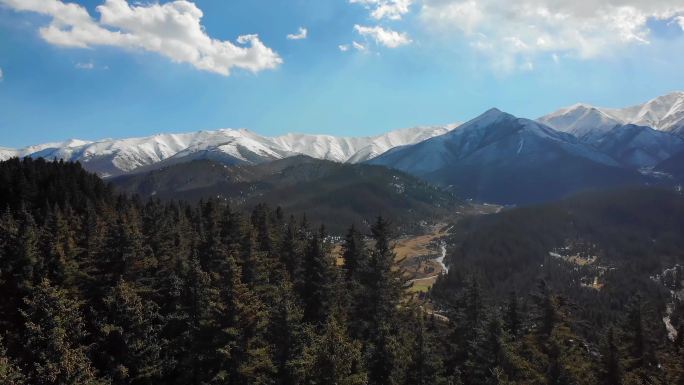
<box><xmin>112</xmin><ymin>156</ymin><xmax>461</xmax><ymax>234</ymax></box>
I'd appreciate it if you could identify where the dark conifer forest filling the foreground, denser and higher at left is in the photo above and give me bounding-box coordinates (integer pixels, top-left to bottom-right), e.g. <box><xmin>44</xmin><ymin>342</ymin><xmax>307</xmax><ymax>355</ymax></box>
<box><xmin>0</xmin><ymin>159</ymin><xmax>684</xmax><ymax>385</ymax></box>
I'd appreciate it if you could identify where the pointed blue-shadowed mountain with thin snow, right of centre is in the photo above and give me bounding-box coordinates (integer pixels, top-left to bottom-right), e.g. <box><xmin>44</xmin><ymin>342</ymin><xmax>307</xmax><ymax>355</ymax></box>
<box><xmin>368</xmin><ymin>109</ymin><xmax>641</xmax><ymax>203</ymax></box>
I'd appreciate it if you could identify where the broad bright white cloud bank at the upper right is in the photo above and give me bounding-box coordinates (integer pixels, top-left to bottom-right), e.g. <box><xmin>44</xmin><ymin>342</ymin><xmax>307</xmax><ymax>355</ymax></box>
<box><xmin>420</xmin><ymin>0</ymin><xmax>684</xmax><ymax>69</ymax></box>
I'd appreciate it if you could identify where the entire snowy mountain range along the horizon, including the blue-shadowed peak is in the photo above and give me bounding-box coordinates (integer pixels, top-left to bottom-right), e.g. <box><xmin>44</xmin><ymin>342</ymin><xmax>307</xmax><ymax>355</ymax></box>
<box><xmin>0</xmin><ymin>92</ymin><xmax>684</xmax><ymax>204</ymax></box>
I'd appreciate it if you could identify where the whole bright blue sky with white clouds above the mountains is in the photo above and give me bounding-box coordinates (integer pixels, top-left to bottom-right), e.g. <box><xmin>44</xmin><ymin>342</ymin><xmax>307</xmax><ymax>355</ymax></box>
<box><xmin>0</xmin><ymin>0</ymin><xmax>684</xmax><ymax>147</ymax></box>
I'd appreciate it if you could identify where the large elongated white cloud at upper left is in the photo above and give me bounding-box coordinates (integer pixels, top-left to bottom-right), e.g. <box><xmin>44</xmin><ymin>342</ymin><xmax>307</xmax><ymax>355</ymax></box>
<box><xmin>0</xmin><ymin>0</ymin><xmax>282</xmax><ymax>76</ymax></box>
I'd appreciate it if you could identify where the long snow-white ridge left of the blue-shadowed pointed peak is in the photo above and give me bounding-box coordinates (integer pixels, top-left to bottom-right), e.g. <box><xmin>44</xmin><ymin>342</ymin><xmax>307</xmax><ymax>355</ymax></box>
<box><xmin>0</xmin><ymin>125</ymin><xmax>455</xmax><ymax>176</ymax></box>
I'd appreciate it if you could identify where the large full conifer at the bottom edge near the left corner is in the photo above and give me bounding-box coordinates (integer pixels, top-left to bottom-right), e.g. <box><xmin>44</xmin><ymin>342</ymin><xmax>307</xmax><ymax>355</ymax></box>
<box><xmin>22</xmin><ymin>279</ymin><xmax>105</xmax><ymax>385</ymax></box>
